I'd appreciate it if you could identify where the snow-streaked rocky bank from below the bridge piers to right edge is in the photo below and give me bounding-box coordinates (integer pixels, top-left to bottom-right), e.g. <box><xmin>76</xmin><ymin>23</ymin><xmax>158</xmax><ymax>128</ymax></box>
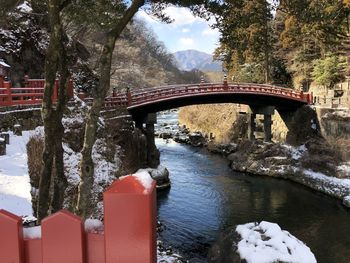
<box><xmin>228</xmin><ymin>142</ymin><xmax>350</xmax><ymax>206</ymax></box>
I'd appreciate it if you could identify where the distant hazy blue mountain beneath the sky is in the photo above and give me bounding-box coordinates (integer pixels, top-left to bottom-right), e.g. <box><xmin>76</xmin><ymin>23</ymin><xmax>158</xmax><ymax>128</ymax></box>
<box><xmin>174</xmin><ymin>50</ymin><xmax>222</xmax><ymax>71</ymax></box>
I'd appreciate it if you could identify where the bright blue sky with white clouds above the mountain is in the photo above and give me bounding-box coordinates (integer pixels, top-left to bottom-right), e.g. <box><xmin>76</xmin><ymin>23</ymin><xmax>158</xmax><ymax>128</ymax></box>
<box><xmin>137</xmin><ymin>6</ymin><xmax>220</xmax><ymax>54</ymax></box>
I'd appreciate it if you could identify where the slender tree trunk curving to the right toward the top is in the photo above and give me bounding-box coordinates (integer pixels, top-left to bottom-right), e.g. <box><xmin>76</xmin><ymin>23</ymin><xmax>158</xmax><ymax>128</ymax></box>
<box><xmin>76</xmin><ymin>0</ymin><xmax>145</xmax><ymax>218</ymax></box>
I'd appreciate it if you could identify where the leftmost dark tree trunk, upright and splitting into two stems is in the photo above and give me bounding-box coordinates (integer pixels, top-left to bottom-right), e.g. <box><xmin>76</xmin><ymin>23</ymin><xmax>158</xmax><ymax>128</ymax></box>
<box><xmin>37</xmin><ymin>0</ymin><xmax>69</xmax><ymax>222</ymax></box>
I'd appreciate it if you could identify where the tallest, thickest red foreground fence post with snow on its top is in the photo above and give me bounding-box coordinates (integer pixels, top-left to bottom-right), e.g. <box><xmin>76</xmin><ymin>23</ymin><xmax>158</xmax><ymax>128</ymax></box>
<box><xmin>103</xmin><ymin>176</ymin><xmax>157</xmax><ymax>263</ymax></box>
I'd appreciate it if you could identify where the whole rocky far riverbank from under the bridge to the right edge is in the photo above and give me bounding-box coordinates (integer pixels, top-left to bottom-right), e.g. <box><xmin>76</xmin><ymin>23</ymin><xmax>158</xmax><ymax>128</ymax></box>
<box><xmin>157</xmin><ymin>109</ymin><xmax>350</xmax><ymax>207</ymax></box>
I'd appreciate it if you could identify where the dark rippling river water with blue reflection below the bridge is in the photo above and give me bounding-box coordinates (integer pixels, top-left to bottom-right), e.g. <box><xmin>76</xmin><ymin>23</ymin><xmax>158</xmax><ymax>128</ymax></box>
<box><xmin>157</xmin><ymin>127</ymin><xmax>350</xmax><ymax>263</ymax></box>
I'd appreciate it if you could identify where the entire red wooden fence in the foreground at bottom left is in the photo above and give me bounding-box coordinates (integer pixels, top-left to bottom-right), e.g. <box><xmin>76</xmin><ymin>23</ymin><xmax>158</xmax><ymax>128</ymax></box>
<box><xmin>0</xmin><ymin>176</ymin><xmax>157</xmax><ymax>263</ymax></box>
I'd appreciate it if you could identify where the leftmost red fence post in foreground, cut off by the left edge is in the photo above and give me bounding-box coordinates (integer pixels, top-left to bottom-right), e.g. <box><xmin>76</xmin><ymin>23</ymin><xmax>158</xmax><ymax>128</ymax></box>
<box><xmin>0</xmin><ymin>209</ymin><xmax>24</xmax><ymax>263</ymax></box>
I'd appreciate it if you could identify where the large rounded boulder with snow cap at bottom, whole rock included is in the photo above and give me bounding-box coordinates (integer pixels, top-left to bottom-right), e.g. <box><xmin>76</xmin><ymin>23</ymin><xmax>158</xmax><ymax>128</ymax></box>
<box><xmin>208</xmin><ymin>221</ymin><xmax>316</xmax><ymax>263</ymax></box>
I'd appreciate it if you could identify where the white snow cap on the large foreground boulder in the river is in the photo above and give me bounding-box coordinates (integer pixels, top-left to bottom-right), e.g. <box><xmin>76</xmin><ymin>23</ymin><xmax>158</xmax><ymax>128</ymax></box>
<box><xmin>236</xmin><ymin>221</ymin><xmax>316</xmax><ymax>263</ymax></box>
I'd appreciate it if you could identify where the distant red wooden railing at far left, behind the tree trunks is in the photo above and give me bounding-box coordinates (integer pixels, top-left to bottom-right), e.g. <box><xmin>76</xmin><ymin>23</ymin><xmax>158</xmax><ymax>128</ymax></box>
<box><xmin>0</xmin><ymin>76</ymin><xmax>73</xmax><ymax>107</ymax></box>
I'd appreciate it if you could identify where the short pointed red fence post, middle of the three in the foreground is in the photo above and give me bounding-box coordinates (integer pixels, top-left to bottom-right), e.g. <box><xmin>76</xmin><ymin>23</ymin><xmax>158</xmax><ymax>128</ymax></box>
<box><xmin>41</xmin><ymin>210</ymin><xmax>85</xmax><ymax>263</ymax></box>
